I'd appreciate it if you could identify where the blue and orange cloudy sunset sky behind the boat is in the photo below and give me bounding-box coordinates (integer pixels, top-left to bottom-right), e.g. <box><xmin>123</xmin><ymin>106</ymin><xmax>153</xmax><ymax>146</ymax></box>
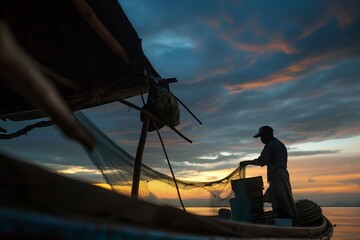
<box><xmin>0</xmin><ymin>0</ymin><xmax>360</xmax><ymax>205</ymax></box>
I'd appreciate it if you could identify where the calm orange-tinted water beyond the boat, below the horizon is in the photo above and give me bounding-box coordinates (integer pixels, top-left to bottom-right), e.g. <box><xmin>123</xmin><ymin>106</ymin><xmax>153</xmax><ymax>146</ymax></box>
<box><xmin>187</xmin><ymin>207</ymin><xmax>360</xmax><ymax>240</ymax></box>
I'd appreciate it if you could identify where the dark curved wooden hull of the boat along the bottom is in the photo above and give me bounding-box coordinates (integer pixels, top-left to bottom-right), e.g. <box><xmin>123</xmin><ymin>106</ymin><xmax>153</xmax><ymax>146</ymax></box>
<box><xmin>0</xmin><ymin>153</ymin><xmax>333</xmax><ymax>239</ymax></box>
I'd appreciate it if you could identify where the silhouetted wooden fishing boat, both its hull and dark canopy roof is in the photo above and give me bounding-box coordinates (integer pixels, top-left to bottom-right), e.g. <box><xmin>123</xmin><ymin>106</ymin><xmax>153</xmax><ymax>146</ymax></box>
<box><xmin>0</xmin><ymin>0</ymin><xmax>333</xmax><ymax>239</ymax></box>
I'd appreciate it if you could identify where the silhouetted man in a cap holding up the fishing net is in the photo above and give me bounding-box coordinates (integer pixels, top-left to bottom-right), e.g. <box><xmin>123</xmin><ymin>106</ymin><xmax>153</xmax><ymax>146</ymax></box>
<box><xmin>240</xmin><ymin>126</ymin><xmax>297</xmax><ymax>223</ymax></box>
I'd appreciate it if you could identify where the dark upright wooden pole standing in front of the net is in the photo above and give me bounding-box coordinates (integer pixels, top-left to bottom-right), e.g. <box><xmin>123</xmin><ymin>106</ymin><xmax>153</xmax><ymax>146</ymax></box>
<box><xmin>131</xmin><ymin>116</ymin><xmax>150</xmax><ymax>198</ymax></box>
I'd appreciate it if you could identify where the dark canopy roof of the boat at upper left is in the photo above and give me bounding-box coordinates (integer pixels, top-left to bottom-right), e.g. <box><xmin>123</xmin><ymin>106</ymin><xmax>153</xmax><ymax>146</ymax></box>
<box><xmin>0</xmin><ymin>0</ymin><xmax>160</xmax><ymax>120</ymax></box>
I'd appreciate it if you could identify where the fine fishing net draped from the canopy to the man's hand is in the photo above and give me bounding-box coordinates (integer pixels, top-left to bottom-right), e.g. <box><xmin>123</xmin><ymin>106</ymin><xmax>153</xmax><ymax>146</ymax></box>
<box><xmin>75</xmin><ymin>112</ymin><xmax>240</xmax><ymax>215</ymax></box>
